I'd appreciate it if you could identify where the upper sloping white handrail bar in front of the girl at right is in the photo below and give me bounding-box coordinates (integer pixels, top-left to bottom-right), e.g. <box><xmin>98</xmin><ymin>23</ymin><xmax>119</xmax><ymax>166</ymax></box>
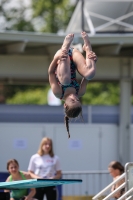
<box><xmin>92</xmin><ymin>173</ymin><xmax>125</xmax><ymax>200</ymax></box>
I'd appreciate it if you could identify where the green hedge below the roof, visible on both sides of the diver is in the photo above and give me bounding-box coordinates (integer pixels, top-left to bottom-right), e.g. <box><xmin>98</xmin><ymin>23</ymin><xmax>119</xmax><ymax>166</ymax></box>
<box><xmin>6</xmin><ymin>82</ymin><xmax>120</xmax><ymax>105</ymax></box>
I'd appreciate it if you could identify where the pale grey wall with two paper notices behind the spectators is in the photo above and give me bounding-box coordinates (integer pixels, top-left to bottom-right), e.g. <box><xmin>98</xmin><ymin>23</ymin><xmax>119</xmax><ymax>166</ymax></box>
<box><xmin>0</xmin><ymin>123</ymin><xmax>118</xmax><ymax>171</ymax></box>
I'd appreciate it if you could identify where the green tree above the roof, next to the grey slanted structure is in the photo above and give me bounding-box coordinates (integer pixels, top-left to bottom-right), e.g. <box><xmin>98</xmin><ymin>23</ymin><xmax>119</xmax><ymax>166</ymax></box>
<box><xmin>32</xmin><ymin>0</ymin><xmax>75</xmax><ymax>33</ymax></box>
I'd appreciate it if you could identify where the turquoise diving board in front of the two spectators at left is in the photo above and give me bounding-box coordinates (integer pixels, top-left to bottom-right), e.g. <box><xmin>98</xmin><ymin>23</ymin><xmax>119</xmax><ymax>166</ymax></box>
<box><xmin>0</xmin><ymin>179</ymin><xmax>82</xmax><ymax>190</ymax></box>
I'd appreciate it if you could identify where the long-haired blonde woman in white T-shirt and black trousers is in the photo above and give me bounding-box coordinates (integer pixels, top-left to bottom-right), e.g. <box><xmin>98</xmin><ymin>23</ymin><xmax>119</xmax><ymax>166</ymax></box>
<box><xmin>28</xmin><ymin>137</ymin><xmax>61</xmax><ymax>200</ymax></box>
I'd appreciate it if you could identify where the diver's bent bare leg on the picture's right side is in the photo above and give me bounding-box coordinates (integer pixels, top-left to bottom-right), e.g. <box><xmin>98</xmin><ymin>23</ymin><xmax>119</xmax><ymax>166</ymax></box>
<box><xmin>73</xmin><ymin>32</ymin><xmax>97</xmax><ymax>80</ymax></box>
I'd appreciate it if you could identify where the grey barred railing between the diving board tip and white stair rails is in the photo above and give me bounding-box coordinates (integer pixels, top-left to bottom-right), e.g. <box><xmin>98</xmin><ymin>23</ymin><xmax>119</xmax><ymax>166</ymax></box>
<box><xmin>62</xmin><ymin>171</ymin><xmax>112</xmax><ymax>196</ymax></box>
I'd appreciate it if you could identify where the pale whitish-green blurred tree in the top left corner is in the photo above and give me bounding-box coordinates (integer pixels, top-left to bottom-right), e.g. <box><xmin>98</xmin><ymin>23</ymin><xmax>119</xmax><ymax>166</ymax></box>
<box><xmin>0</xmin><ymin>0</ymin><xmax>34</xmax><ymax>31</ymax></box>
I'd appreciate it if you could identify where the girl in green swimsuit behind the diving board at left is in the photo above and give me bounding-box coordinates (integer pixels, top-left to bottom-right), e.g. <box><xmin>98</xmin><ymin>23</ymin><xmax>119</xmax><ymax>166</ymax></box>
<box><xmin>4</xmin><ymin>159</ymin><xmax>36</xmax><ymax>200</ymax></box>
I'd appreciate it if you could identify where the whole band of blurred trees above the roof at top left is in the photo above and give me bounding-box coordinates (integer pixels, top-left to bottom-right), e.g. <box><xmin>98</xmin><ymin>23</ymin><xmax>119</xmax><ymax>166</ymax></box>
<box><xmin>0</xmin><ymin>0</ymin><xmax>76</xmax><ymax>33</ymax></box>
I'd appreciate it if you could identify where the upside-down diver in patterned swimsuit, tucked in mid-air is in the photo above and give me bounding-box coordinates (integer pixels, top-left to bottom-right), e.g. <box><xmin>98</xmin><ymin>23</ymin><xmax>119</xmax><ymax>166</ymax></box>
<box><xmin>48</xmin><ymin>32</ymin><xmax>97</xmax><ymax>137</ymax></box>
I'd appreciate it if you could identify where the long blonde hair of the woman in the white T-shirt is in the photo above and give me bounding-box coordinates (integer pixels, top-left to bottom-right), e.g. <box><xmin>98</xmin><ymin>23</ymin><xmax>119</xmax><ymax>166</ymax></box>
<box><xmin>37</xmin><ymin>137</ymin><xmax>54</xmax><ymax>157</ymax></box>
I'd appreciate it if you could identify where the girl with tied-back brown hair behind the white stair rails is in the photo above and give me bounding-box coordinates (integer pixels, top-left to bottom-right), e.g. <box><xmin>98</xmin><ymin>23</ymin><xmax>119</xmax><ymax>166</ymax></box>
<box><xmin>108</xmin><ymin>161</ymin><xmax>125</xmax><ymax>199</ymax></box>
